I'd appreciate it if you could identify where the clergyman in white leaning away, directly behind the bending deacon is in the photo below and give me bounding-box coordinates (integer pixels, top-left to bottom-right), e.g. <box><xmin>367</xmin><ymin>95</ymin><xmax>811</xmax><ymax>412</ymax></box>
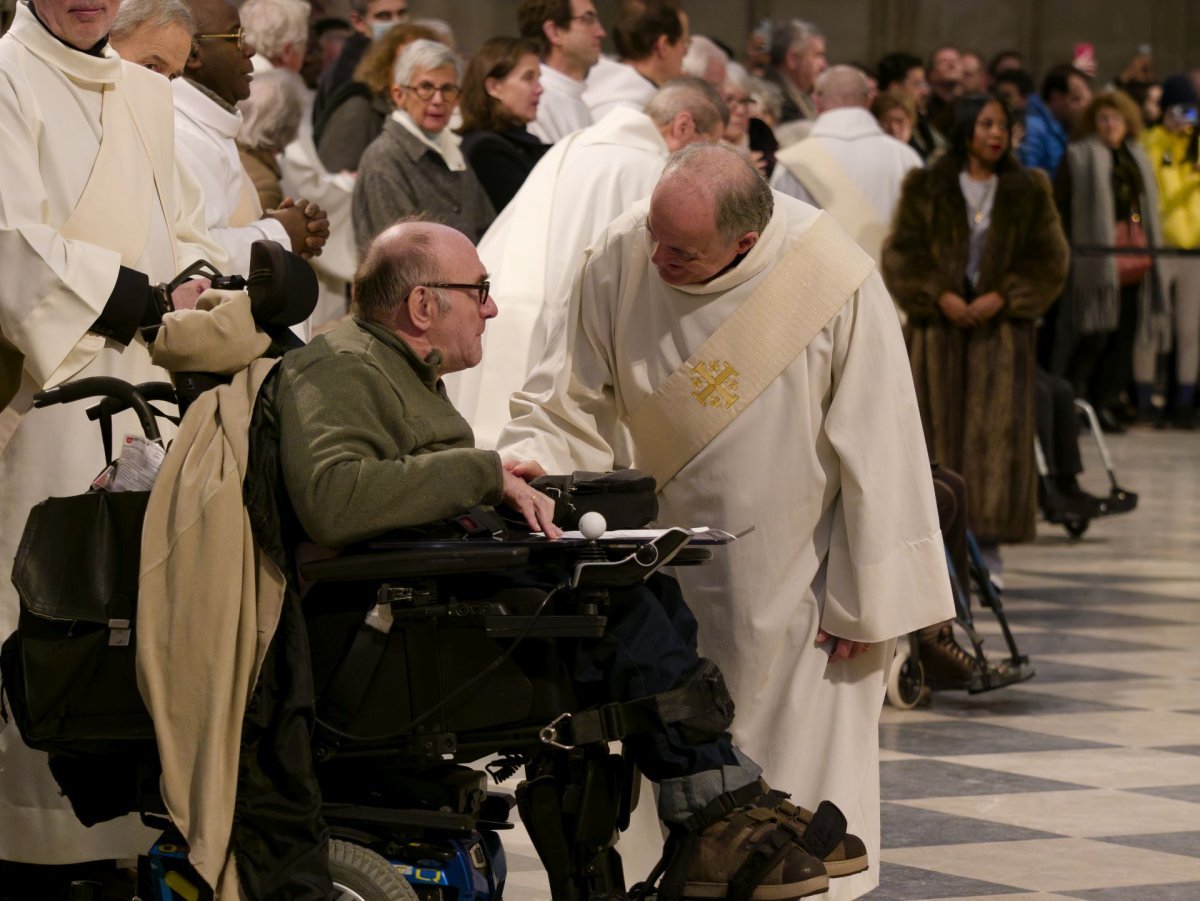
<box><xmin>445</xmin><ymin>78</ymin><xmax>728</xmax><ymax>448</ymax></box>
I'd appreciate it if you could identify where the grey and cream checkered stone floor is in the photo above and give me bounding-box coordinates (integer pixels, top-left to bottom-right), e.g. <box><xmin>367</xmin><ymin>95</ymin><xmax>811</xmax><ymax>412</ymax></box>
<box><xmin>496</xmin><ymin>431</ymin><xmax>1200</xmax><ymax>901</ymax></box>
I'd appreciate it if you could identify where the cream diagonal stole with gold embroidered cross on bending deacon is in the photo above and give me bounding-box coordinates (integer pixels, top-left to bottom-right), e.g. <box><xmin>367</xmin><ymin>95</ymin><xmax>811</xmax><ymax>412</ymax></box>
<box><xmin>629</xmin><ymin>214</ymin><xmax>874</xmax><ymax>491</ymax></box>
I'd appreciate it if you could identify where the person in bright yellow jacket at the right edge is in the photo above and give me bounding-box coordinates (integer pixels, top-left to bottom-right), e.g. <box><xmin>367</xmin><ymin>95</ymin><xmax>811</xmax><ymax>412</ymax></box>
<box><xmin>1138</xmin><ymin>76</ymin><xmax>1200</xmax><ymax>430</ymax></box>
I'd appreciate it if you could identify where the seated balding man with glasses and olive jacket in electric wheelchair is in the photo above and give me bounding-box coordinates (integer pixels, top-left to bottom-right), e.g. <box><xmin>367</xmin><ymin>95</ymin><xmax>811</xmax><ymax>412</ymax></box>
<box><xmin>265</xmin><ymin>221</ymin><xmax>866</xmax><ymax>899</ymax></box>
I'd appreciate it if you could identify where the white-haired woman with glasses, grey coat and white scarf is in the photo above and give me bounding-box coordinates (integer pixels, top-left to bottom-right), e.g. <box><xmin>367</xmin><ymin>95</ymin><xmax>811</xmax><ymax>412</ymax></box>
<box><xmin>352</xmin><ymin>41</ymin><xmax>496</xmax><ymax>257</ymax></box>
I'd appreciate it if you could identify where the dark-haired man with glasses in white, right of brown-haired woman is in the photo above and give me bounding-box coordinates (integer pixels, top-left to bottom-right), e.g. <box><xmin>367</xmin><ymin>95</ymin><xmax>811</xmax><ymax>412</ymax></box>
<box><xmin>517</xmin><ymin>0</ymin><xmax>605</xmax><ymax>144</ymax></box>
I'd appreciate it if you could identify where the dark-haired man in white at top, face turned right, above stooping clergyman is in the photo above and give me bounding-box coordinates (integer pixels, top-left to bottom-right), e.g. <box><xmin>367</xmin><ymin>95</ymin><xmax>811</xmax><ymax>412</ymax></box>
<box><xmin>583</xmin><ymin>0</ymin><xmax>688</xmax><ymax>122</ymax></box>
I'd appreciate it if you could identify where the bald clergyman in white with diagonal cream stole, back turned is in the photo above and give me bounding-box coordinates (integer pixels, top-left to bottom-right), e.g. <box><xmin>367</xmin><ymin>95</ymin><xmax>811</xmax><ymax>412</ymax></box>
<box><xmin>770</xmin><ymin>66</ymin><xmax>922</xmax><ymax>262</ymax></box>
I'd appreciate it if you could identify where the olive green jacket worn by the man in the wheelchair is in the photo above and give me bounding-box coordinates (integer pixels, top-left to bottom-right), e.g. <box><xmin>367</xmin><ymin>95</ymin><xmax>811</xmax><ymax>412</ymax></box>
<box><xmin>275</xmin><ymin>319</ymin><xmax>504</xmax><ymax>547</ymax></box>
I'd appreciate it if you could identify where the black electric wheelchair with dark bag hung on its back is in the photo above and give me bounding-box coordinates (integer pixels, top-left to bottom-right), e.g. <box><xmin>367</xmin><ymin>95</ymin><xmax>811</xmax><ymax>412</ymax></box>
<box><xmin>0</xmin><ymin>248</ymin><xmax>748</xmax><ymax>901</ymax></box>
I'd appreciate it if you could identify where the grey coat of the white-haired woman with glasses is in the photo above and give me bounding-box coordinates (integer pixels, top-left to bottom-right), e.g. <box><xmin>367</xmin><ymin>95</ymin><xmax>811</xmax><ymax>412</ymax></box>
<box><xmin>352</xmin><ymin>119</ymin><xmax>496</xmax><ymax>258</ymax></box>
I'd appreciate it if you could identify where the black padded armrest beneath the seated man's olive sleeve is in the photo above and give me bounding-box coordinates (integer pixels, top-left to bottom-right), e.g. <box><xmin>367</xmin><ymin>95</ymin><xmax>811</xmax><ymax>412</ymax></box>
<box><xmin>299</xmin><ymin>542</ymin><xmax>529</xmax><ymax>583</ymax></box>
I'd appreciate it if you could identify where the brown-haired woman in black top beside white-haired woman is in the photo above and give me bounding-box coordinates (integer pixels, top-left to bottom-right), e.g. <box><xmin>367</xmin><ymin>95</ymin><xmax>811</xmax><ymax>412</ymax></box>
<box><xmin>458</xmin><ymin>37</ymin><xmax>550</xmax><ymax>212</ymax></box>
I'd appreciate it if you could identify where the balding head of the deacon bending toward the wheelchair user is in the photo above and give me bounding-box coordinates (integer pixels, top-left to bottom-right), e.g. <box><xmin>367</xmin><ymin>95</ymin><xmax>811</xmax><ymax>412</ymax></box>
<box><xmin>647</xmin><ymin>144</ymin><xmax>774</xmax><ymax>286</ymax></box>
